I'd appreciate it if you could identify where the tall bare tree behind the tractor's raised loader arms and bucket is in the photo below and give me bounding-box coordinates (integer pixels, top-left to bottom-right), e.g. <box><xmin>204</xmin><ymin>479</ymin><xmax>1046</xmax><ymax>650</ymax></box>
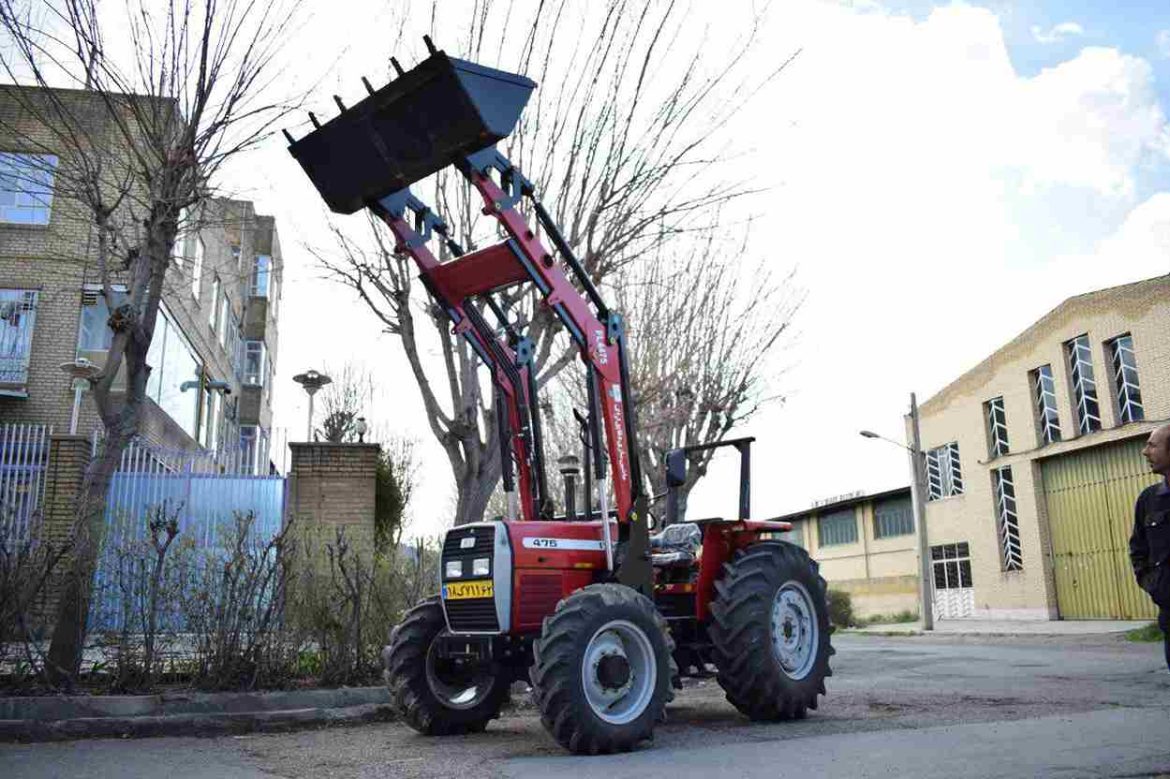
<box><xmin>316</xmin><ymin>0</ymin><xmax>784</xmax><ymax>524</ymax></box>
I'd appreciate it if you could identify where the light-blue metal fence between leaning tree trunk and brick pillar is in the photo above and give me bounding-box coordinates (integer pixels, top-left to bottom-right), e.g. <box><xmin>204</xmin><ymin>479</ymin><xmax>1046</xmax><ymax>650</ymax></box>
<box><xmin>90</xmin><ymin>442</ymin><xmax>285</xmax><ymax>630</ymax></box>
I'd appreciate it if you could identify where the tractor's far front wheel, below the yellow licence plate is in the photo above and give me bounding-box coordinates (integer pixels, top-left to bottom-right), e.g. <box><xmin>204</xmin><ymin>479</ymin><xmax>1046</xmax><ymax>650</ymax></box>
<box><xmin>383</xmin><ymin>598</ymin><xmax>509</xmax><ymax>736</ymax></box>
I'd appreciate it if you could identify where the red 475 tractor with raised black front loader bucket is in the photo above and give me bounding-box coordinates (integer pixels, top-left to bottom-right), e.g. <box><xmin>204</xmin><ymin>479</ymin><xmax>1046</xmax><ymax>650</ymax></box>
<box><xmin>288</xmin><ymin>39</ymin><xmax>833</xmax><ymax>754</ymax></box>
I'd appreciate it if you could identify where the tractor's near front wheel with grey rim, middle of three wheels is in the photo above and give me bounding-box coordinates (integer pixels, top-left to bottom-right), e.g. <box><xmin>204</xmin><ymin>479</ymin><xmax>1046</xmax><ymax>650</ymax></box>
<box><xmin>530</xmin><ymin>584</ymin><xmax>676</xmax><ymax>754</ymax></box>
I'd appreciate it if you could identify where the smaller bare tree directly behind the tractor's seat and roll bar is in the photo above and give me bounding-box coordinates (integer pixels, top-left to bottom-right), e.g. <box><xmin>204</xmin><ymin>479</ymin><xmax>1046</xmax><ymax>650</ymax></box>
<box><xmin>617</xmin><ymin>235</ymin><xmax>804</xmax><ymax>519</ymax></box>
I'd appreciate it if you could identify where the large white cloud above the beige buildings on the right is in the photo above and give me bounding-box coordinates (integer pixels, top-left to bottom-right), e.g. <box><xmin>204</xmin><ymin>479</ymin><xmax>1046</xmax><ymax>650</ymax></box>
<box><xmin>696</xmin><ymin>4</ymin><xmax>1170</xmax><ymax>516</ymax></box>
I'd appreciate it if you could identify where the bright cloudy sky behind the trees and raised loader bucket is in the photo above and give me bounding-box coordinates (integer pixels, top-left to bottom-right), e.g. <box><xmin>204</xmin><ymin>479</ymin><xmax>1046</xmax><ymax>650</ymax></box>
<box><xmin>210</xmin><ymin>0</ymin><xmax>1170</xmax><ymax>535</ymax></box>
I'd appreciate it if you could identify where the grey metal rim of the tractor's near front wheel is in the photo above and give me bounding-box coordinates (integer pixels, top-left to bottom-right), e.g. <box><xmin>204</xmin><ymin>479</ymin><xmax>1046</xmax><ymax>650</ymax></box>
<box><xmin>581</xmin><ymin>620</ymin><xmax>658</xmax><ymax>725</ymax></box>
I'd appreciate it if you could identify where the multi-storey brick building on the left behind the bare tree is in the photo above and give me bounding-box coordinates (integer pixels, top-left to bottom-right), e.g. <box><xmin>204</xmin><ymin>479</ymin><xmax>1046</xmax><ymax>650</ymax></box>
<box><xmin>0</xmin><ymin>85</ymin><xmax>282</xmax><ymax>471</ymax></box>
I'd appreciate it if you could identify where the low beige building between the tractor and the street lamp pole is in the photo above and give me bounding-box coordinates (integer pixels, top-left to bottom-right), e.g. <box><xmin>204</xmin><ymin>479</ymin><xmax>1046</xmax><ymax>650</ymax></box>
<box><xmin>780</xmin><ymin>487</ymin><xmax>918</xmax><ymax>616</ymax></box>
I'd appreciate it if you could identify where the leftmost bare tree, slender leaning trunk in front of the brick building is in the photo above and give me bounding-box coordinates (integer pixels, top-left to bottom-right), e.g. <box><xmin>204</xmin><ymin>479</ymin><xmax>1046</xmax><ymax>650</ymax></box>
<box><xmin>0</xmin><ymin>0</ymin><xmax>306</xmax><ymax>680</ymax></box>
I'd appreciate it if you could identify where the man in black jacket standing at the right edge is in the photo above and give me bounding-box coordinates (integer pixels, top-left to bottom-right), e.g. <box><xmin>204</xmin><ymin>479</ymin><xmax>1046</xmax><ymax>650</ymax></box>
<box><xmin>1129</xmin><ymin>425</ymin><xmax>1170</xmax><ymax>668</ymax></box>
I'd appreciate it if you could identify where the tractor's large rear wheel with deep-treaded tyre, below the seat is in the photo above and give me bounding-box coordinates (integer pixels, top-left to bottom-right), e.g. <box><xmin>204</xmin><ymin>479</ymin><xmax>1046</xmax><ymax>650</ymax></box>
<box><xmin>709</xmin><ymin>542</ymin><xmax>833</xmax><ymax>721</ymax></box>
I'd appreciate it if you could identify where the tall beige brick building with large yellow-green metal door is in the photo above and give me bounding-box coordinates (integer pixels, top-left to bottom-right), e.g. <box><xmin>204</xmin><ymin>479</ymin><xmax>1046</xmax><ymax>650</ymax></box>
<box><xmin>920</xmin><ymin>276</ymin><xmax>1170</xmax><ymax>619</ymax></box>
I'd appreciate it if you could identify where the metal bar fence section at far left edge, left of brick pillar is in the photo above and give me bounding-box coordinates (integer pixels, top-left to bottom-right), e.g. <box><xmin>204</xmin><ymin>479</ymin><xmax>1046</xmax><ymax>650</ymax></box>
<box><xmin>0</xmin><ymin>422</ymin><xmax>51</xmax><ymax>544</ymax></box>
